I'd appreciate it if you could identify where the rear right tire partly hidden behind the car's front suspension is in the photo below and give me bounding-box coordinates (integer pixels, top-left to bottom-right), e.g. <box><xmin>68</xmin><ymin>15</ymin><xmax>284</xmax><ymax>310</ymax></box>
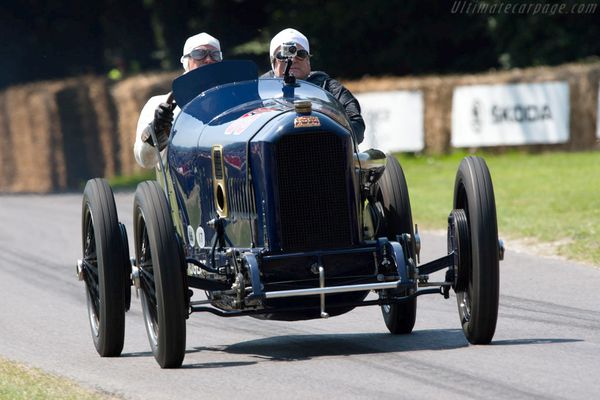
<box><xmin>378</xmin><ymin>155</ymin><xmax>417</xmax><ymax>334</ymax></box>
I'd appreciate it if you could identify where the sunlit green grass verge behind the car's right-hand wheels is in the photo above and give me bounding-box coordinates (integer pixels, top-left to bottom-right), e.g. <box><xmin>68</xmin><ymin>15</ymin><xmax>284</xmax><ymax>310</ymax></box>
<box><xmin>398</xmin><ymin>151</ymin><xmax>600</xmax><ymax>265</ymax></box>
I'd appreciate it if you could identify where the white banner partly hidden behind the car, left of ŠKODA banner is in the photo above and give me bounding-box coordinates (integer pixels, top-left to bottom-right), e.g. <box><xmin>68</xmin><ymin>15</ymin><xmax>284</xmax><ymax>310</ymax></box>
<box><xmin>356</xmin><ymin>91</ymin><xmax>425</xmax><ymax>153</ymax></box>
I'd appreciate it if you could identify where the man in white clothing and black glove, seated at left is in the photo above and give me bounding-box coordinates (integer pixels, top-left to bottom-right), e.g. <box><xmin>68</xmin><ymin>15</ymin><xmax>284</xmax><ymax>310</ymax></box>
<box><xmin>133</xmin><ymin>32</ymin><xmax>223</xmax><ymax>168</ymax></box>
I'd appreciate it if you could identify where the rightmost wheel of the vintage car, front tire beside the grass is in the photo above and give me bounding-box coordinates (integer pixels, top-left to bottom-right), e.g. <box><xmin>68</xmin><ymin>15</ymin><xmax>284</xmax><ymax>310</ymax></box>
<box><xmin>454</xmin><ymin>156</ymin><xmax>500</xmax><ymax>344</ymax></box>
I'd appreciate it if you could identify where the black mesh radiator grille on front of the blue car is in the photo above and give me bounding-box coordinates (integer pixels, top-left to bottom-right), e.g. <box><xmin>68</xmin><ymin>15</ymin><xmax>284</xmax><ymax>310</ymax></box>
<box><xmin>276</xmin><ymin>132</ymin><xmax>352</xmax><ymax>251</ymax></box>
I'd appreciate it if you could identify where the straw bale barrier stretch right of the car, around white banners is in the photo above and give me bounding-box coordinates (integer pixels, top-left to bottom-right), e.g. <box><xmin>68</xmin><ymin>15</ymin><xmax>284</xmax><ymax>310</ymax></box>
<box><xmin>345</xmin><ymin>62</ymin><xmax>600</xmax><ymax>153</ymax></box>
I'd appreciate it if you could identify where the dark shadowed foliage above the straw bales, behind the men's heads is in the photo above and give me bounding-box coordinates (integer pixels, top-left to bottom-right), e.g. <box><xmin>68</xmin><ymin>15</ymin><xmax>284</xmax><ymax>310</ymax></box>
<box><xmin>0</xmin><ymin>0</ymin><xmax>600</xmax><ymax>88</ymax></box>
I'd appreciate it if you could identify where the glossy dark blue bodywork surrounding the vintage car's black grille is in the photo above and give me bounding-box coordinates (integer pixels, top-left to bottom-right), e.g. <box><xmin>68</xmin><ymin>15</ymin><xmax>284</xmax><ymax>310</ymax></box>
<box><xmin>168</xmin><ymin>64</ymin><xmax>359</xmax><ymax>252</ymax></box>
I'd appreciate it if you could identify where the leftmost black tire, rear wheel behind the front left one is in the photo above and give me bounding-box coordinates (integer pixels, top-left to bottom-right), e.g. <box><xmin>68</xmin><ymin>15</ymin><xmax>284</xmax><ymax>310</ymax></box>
<box><xmin>82</xmin><ymin>179</ymin><xmax>125</xmax><ymax>357</ymax></box>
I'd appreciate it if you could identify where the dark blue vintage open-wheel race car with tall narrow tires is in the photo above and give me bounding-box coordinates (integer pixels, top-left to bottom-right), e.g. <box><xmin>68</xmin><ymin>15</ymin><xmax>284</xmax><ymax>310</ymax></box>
<box><xmin>77</xmin><ymin>61</ymin><xmax>503</xmax><ymax>368</ymax></box>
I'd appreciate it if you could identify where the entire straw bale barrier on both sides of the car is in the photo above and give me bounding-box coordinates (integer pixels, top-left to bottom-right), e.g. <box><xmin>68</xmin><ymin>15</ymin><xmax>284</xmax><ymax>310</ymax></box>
<box><xmin>0</xmin><ymin>62</ymin><xmax>600</xmax><ymax>193</ymax></box>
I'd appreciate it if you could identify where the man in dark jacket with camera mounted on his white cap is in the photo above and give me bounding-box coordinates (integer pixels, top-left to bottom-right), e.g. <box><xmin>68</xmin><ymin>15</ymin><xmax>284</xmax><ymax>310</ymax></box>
<box><xmin>261</xmin><ymin>28</ymin><xmax>365</xmax><ymax>143</ymax></box>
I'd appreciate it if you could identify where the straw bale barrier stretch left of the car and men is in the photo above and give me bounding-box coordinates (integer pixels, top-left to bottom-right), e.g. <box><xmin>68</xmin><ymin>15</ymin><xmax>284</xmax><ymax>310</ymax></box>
<box><xmin>0</xmin><ymin>73</ymin><xmax>176</xmax><ymax>193</ymax></box>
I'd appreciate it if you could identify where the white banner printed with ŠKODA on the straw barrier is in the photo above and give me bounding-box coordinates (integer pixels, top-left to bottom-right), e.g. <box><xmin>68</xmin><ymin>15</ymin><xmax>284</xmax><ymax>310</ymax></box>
<box><xmin>452</xmin><ymin>82</ymin><xmax>569</xmax><ymax>147</ymax></box>
